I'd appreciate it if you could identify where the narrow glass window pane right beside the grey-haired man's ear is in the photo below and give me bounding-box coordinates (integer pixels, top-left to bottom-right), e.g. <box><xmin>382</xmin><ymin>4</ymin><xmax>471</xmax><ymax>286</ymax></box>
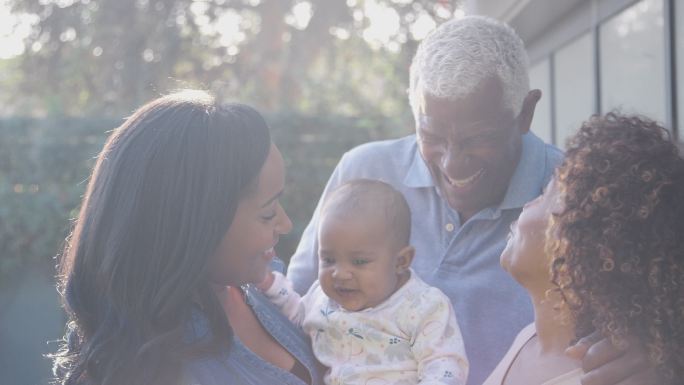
<box><xmin>530</xmin><ymin>59</ymin><xmax>551</xmax><ymax>143</ymax></box>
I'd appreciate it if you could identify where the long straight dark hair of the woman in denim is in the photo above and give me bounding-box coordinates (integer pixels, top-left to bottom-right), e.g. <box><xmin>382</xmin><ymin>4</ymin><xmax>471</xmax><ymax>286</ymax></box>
<box><xmin>53</xmin><ymin>91</ymin><xmax>270</xmax><ymax>385</ymax></box>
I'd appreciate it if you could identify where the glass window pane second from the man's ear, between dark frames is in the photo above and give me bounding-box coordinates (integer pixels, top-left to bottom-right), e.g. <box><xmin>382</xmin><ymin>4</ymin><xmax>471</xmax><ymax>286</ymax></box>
<box><xmin>553</xmin><ymin>33</ymin><xmax>596</xmax><ymax>147</ymax></box>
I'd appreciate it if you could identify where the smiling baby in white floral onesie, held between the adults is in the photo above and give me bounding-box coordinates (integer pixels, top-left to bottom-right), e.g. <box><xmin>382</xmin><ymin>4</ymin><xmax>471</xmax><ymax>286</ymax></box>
<box><xmin>260</xmin><ymin>179</ymin><xmax>468</xmax><ymax>385</ymax></box>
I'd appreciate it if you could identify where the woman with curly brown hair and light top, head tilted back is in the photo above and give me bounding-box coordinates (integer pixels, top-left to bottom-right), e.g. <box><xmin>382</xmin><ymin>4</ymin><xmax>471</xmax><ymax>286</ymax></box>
<box><xmin>485</xmin><ymin>113</ymin><xmax>684</xmax><ymax>385</ymax></box>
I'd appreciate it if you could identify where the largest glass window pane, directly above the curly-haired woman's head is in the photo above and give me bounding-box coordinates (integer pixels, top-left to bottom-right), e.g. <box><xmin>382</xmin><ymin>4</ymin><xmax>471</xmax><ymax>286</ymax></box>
<box><xmin>599</xmin><ymin>0</ymin><xmax>667</xmax><ymax>122</ymax></box>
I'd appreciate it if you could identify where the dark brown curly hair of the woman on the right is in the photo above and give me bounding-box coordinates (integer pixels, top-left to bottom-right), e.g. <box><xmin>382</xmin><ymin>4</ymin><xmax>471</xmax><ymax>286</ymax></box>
<box><xmin>547</xmin><ymin>113</ymin><xmax>684</xmax><ymax>383</ymax></box>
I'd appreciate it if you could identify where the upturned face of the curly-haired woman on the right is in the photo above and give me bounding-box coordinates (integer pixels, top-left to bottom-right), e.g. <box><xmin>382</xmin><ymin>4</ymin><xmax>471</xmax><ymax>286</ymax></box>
<box><xmin>501</xmin><ymin>179</ymin><xmax>561</xmax><ymax>289</ymax></box>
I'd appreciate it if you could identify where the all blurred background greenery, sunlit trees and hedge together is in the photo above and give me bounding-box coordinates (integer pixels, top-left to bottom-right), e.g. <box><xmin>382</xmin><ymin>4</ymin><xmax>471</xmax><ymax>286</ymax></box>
<box><xmin>0</xmin><ymin>0</ymin><xmax>448</xmax><ymax>282</ymax></box>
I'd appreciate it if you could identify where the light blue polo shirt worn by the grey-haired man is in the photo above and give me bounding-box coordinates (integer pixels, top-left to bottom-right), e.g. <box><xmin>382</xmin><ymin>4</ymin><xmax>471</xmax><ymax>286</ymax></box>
<box><xmin>287</xmin><ymin>133</ymin><xmax>563</xmax><ymax>385</ymax></box>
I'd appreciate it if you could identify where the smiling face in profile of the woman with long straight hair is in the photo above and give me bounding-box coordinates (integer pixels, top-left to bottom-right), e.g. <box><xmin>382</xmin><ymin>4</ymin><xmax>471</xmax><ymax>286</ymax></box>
<box><xmin>209</xmin><ymin>144</ymin><xmax>292</xmax><ymax>286</ymax></box>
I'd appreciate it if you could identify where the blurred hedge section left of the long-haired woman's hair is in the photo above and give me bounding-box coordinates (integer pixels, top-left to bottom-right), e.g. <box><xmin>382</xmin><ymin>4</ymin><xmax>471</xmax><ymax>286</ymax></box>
<box><xmin>0</xmin><ymin>118</ymin><xmax>116</xmax><ymax>276</ymax></box>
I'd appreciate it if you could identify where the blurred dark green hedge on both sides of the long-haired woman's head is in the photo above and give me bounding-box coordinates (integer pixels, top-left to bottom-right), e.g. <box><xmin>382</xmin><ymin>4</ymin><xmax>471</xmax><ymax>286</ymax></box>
<box><xmin>0</xmin><ymin>112</ymin><xmax>407</xmax><ymax>282</ymax></box>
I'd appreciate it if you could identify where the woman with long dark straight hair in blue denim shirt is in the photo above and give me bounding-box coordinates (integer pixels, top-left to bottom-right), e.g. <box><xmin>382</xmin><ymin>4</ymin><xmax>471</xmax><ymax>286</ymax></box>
<box><xmin>54</xmin><ymin>91</ymin><xmax>320</xmax><ymax>385</ymax></box>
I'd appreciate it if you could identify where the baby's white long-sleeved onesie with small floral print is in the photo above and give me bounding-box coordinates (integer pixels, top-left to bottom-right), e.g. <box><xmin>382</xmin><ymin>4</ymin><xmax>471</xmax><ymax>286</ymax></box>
<box><xmin>265</xmin><ymin>271</ymin><xmax>468</xmax><ymax>385</ymax></box>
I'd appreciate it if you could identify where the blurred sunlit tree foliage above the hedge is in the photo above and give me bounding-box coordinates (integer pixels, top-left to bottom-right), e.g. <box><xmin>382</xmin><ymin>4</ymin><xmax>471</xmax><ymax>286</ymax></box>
<box><xmin>0</xmin><ymin>0</ymin><xmax>460</xmax><ymax>116</ymax></box>
